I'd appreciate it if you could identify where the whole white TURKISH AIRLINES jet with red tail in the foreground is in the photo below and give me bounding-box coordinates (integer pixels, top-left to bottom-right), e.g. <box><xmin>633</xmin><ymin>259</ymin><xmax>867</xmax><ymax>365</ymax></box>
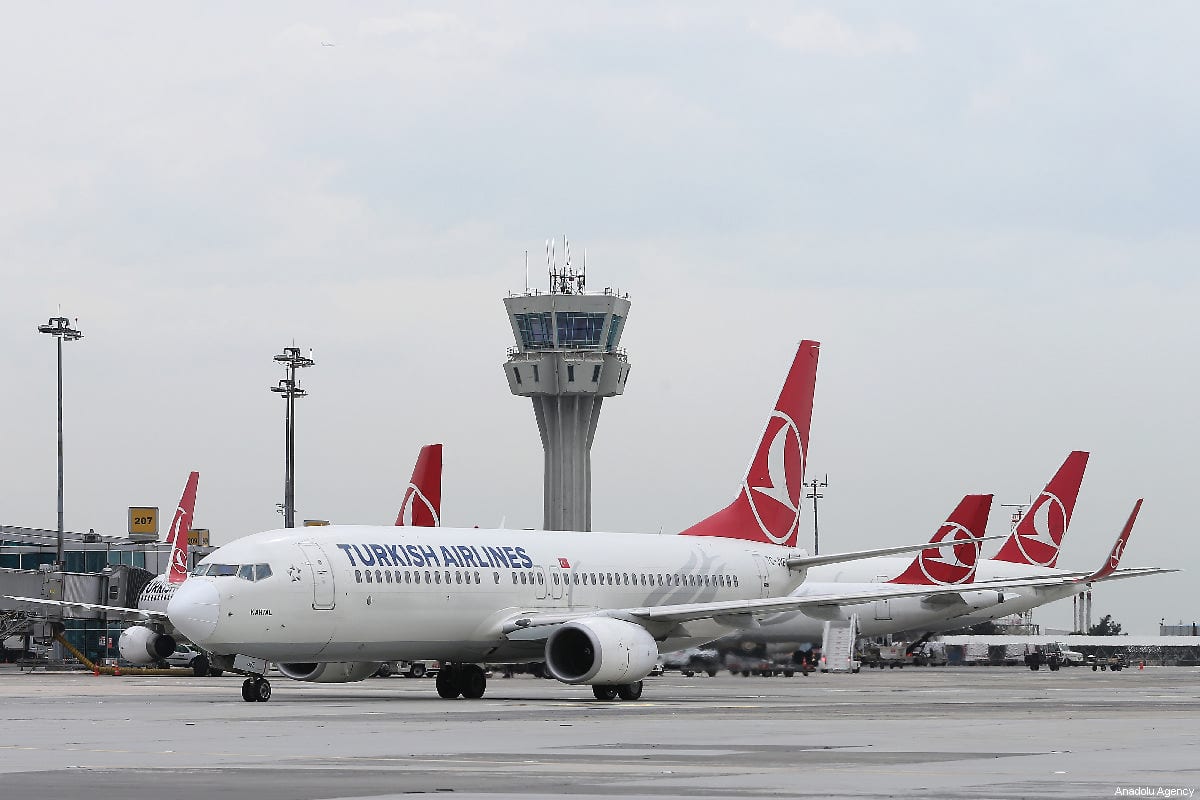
<box><xmin>167</xmin><ymin>341</ymin><xmax>1046</xmax><ymax>702</ymax></box>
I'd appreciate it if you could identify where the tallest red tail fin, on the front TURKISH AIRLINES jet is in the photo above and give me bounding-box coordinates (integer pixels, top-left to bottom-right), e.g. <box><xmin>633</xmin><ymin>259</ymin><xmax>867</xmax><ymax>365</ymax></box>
<box><xmin>682</xmin><ymin>339</ymin><xmax>821</xmax><ymax>547</ymax></box>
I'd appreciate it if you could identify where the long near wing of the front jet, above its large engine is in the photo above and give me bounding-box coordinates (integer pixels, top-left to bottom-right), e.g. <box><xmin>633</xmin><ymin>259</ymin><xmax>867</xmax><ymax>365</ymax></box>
<box><xmin>502</xmin><ymin>575</ymin><xmax>1068</xmax><ymax>639</ymax></box>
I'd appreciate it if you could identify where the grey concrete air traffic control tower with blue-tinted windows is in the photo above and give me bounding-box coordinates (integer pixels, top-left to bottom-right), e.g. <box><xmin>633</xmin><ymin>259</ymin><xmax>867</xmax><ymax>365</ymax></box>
<box><xmin>504</xmin><ymin>259</ymin><xmax>629</xmax><ymax>530</ymax></box>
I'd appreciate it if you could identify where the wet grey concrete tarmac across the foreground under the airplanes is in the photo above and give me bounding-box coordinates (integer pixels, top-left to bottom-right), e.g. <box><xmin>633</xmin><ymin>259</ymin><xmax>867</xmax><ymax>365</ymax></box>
<box><xmin>0</xmin><ymin>667</ymin><xmax>1200</xmax><ymax>800</ymax></box>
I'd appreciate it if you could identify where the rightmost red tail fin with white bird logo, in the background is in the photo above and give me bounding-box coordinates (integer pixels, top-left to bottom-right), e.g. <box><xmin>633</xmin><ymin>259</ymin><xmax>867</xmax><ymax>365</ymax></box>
<box><xmin>992</xmin><ymin>450</ymin><xmax>1087</xmax><ymax>567</ymax></box>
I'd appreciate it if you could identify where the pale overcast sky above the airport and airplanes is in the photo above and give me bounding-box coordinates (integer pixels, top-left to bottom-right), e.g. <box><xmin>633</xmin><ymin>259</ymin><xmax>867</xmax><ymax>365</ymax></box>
<box><xmin>0</xmin><ymin>2</ymin><xmax>1200</xmax><ymax>633</ymax></box>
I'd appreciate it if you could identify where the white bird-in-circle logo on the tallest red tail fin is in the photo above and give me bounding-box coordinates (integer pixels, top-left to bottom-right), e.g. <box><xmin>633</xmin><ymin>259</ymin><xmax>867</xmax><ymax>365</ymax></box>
<box><xmin>744</xmin><ymin>409</ymin><xmax>804</xmax><ymax>545</ymax></box>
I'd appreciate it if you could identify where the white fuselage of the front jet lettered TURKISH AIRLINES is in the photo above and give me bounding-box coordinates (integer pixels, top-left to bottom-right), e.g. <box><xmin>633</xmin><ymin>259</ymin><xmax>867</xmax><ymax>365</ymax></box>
<box><xmin>168</xmin><ymin>525</ymin><xmax>804</xmax><ymax>662</ymax></box>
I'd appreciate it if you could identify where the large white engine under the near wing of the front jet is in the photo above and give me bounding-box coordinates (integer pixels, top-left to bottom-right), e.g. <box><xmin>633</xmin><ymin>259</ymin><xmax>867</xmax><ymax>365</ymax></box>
<box><xmin>546</xmin><ymin>616</ymin><xmax>659</xmax><ymax>685</ymax></box>
